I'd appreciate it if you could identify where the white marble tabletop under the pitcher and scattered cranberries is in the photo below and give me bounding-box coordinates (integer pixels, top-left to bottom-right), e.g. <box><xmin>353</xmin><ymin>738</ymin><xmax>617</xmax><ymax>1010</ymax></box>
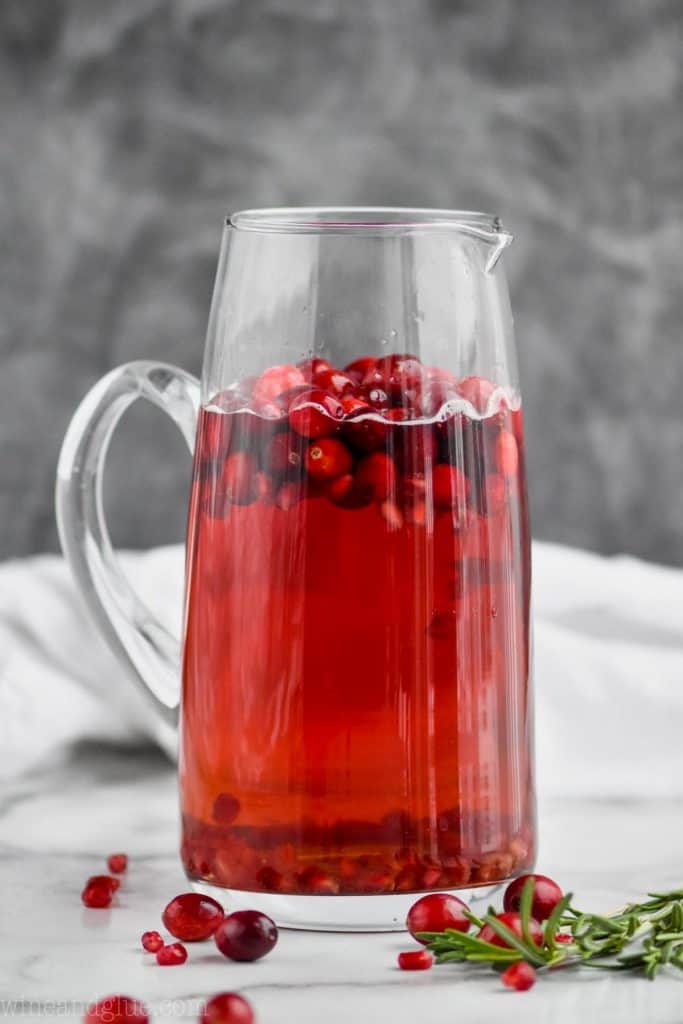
<box><xmin>0</xmin><ymin>745</ymin><xmax>683</xmax><ymax>1024</ymax></box>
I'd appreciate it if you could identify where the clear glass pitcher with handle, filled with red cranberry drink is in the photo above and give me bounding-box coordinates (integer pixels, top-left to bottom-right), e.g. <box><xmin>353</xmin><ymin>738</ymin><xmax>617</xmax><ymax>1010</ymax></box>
<box><xmin>57</xmin><ymin>209</ymin><xmax>535</xmax><ymax>930</ymax></box>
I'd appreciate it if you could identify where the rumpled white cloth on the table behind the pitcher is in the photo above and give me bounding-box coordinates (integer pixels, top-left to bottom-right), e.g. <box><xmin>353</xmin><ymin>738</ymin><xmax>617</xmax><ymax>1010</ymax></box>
<box><xmin>0</xmin><ymin>542</ymin><xmax>683</xmax><ymax>798</ymax></box>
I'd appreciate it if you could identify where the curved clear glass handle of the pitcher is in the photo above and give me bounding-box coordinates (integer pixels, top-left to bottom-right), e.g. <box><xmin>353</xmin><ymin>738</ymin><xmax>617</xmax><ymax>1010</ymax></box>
<box><xmin>56</xmin><ymin>361</ymin><xmax>200</xmax><ymax>753</ymax></box>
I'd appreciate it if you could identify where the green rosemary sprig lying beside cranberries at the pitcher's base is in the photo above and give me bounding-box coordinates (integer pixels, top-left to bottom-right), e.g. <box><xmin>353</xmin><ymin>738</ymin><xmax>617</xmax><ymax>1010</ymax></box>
<box><xmin>420</xmin><ymin>879</ymin><xmax>683</xmax><ymax>980</ymax></box>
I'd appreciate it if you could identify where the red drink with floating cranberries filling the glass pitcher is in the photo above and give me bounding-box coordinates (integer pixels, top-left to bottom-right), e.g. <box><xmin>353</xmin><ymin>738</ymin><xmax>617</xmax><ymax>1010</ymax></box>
<box><xmin>180</xmin><ymin>355</ymin><xmax>535</xmax><ymax>894</ymax></box>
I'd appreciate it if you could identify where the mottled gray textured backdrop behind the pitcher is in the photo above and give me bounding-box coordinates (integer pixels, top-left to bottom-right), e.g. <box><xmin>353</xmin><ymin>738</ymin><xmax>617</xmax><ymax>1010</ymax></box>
<box><xmin>0</xmin><ymin>0</ymin><xmax>683</xmax><ymax>564</ymax></box>
